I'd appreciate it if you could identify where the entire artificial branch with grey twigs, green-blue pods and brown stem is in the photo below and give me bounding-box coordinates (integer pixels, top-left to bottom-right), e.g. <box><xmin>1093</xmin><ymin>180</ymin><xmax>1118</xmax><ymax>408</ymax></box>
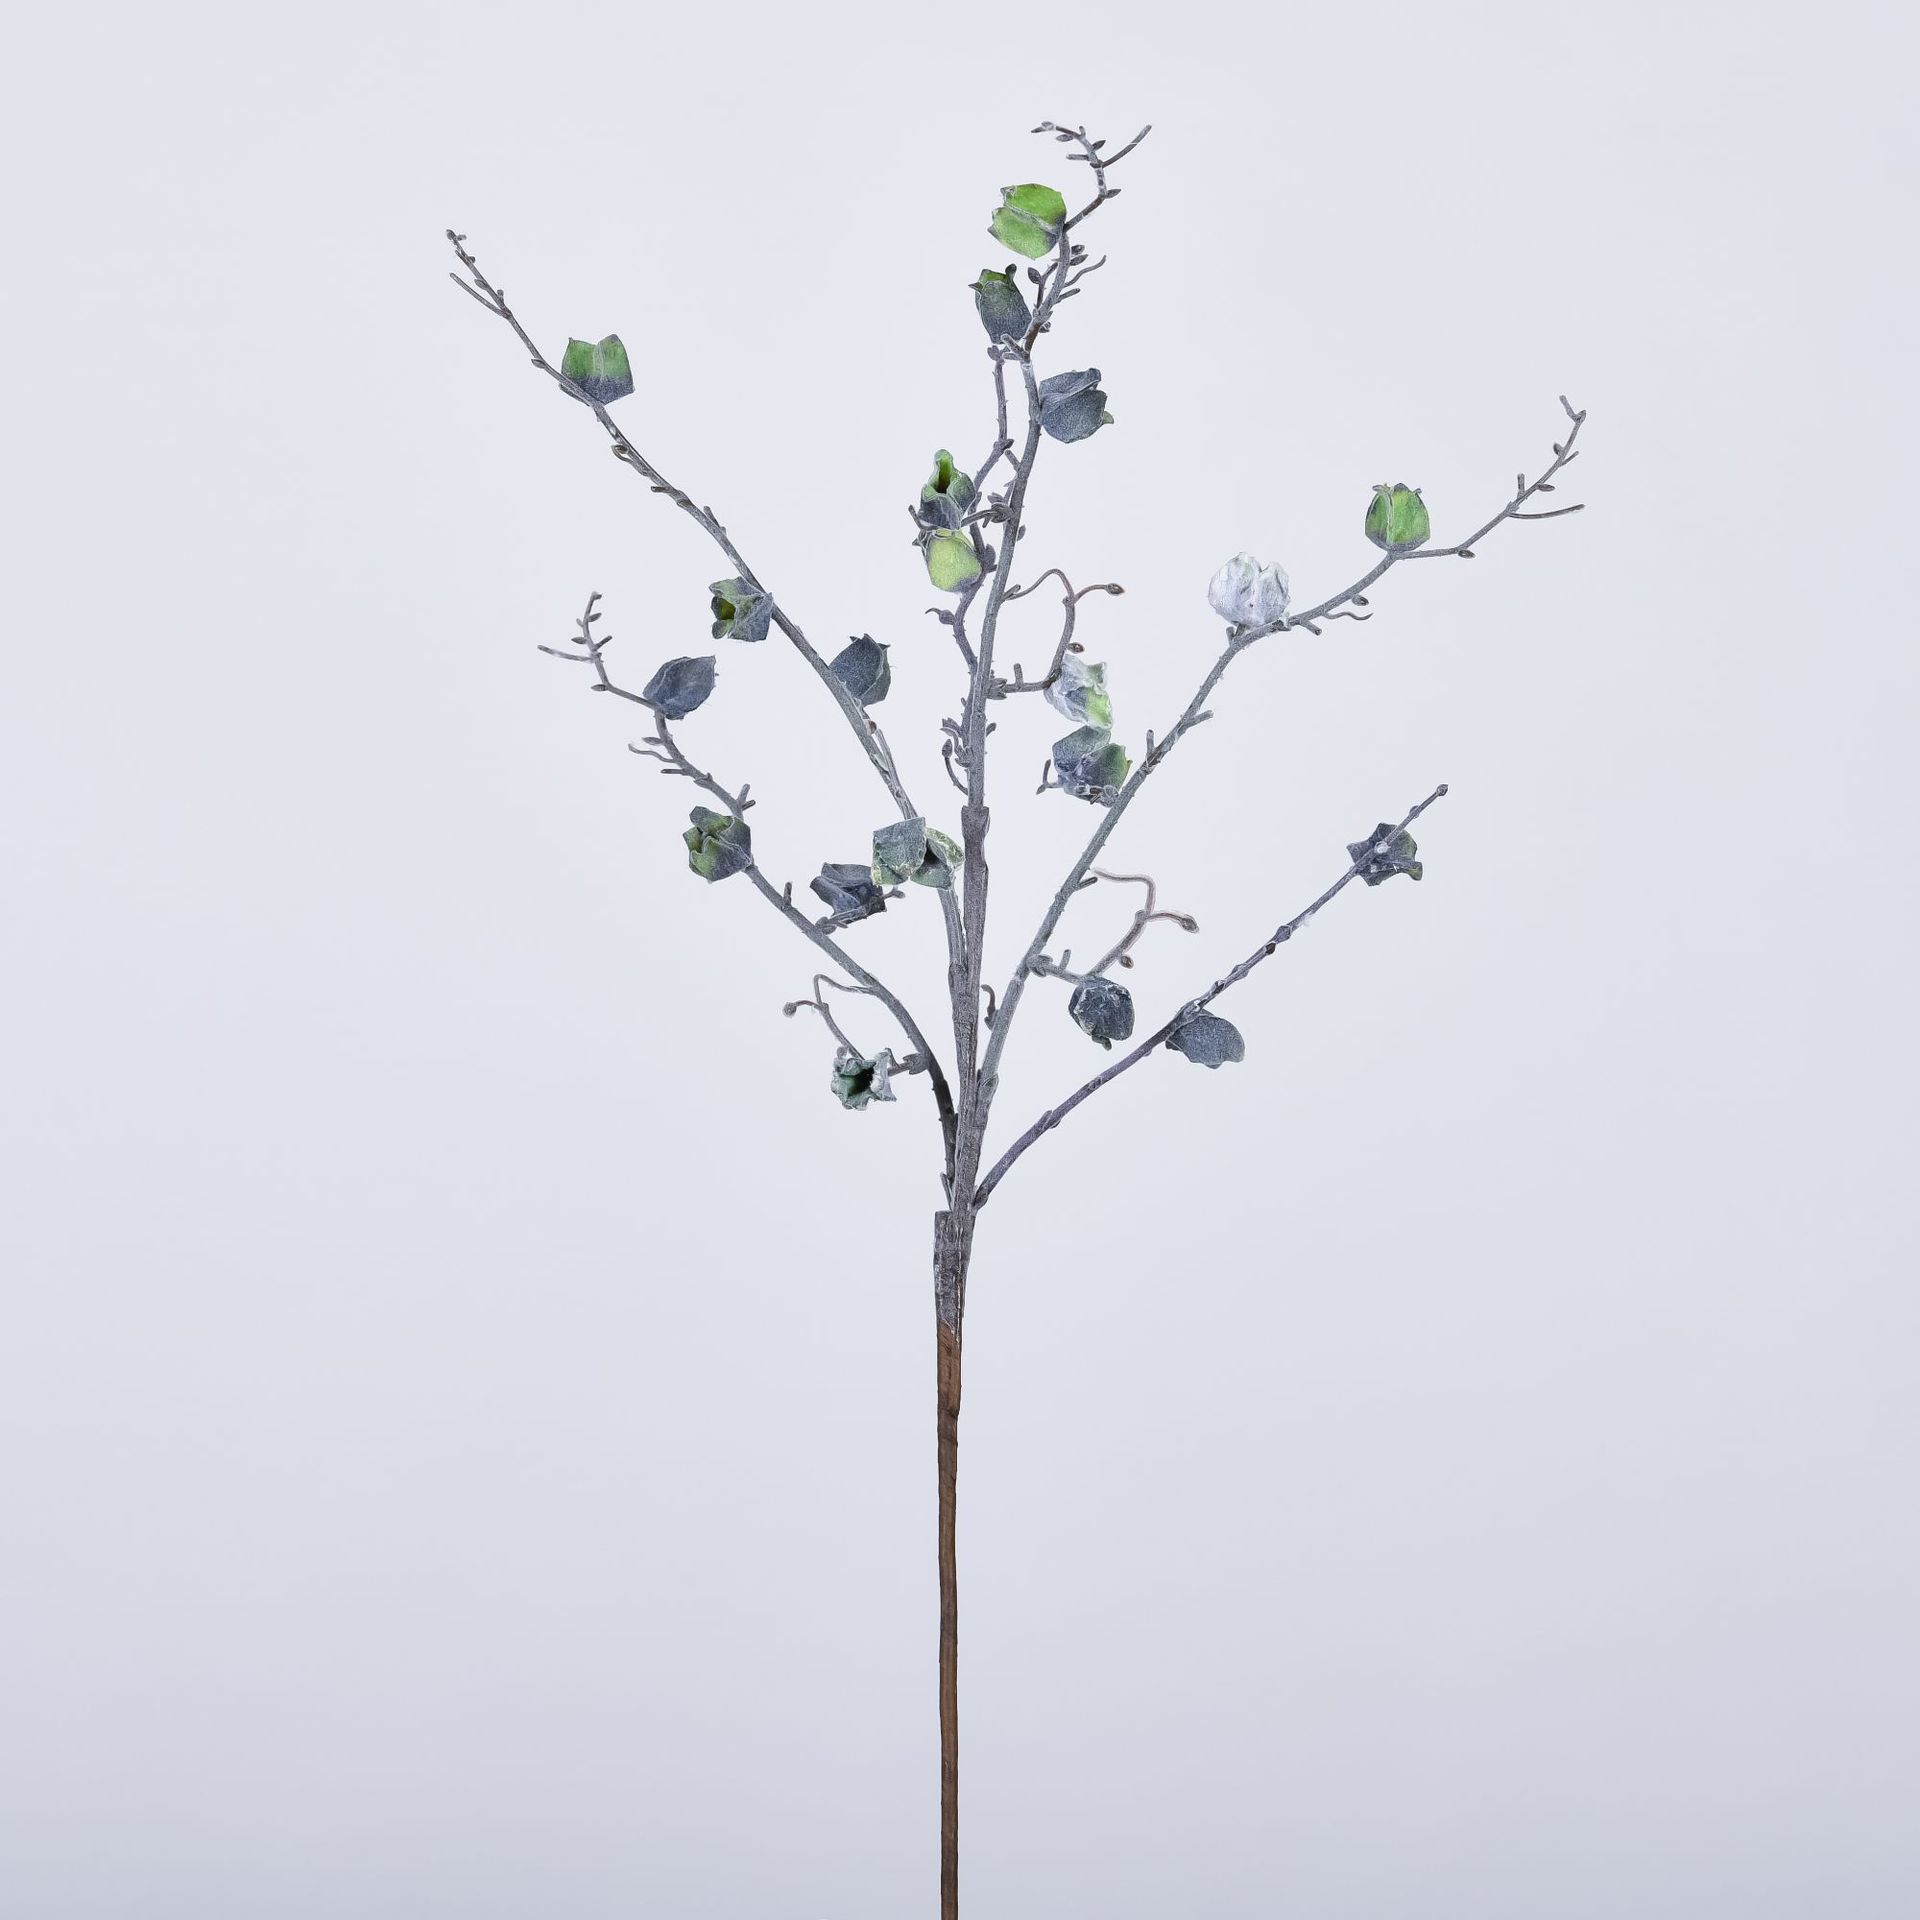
<box><xmin>447</xmin><ymin>121</ymin><xmax>1586</xmax><ymax>1920</ymax></box>
